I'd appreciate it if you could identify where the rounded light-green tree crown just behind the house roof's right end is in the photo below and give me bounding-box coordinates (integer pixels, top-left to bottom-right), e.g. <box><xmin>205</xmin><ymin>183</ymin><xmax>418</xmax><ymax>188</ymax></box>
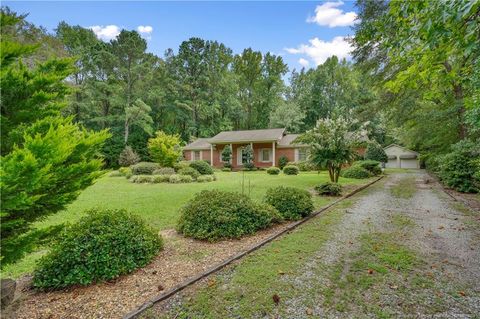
<box><xmin>270</xmin><ymin>101</ymin><xmax>305</xmax><ymax>133</ymax></box>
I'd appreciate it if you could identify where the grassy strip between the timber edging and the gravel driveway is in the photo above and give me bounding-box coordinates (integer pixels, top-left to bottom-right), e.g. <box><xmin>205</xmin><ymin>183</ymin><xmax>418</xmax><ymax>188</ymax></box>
<box><xmin>144</xmin><ymin>200</ymin><xmax>352</xmax><ymax>318</ymax></box>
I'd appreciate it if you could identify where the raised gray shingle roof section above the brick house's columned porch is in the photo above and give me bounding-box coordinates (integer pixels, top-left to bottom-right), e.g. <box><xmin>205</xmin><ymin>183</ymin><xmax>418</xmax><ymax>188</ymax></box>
<box><xmin>208</xmin><ymin>128</ymin><xmax>285</xmax><ymax>144</ymax></box>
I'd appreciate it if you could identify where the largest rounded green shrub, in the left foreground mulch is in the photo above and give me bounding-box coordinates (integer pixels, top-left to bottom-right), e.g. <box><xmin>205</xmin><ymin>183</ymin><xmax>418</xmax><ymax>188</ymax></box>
<box><xmin>33</xmin><ymin>210</ymin><xmax>162</xmax><ymax>289</ymax></box>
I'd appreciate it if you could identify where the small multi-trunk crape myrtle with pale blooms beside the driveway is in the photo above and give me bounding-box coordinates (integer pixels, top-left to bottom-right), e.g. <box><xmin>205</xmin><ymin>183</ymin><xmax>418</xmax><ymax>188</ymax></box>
<box><xmin>296</xmin><ymin>116</ymin><xmax>366</xmax><ymax>183</ymax></box>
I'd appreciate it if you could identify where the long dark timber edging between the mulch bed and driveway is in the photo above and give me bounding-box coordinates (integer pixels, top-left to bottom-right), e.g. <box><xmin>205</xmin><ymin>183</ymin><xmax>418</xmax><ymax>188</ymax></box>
<box><xmin>123</xmin><ymin>175</ymin><xmax>385</xmax><ymax>319</ymax></box>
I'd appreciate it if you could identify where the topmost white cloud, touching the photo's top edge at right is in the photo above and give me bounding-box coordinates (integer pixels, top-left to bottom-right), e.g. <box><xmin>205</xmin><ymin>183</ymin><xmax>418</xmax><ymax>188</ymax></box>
<box><xmin>307</xmin><ymin>1</ymin><xmax>357</xmax><ymax>28</ymax></box>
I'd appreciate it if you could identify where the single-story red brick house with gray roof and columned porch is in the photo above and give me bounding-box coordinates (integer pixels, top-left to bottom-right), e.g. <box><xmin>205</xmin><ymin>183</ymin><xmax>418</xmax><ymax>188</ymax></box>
<box><xmin>183</xmin><ymin>128</ymin><xmax>307</xmax><ymax>169</ymax></box>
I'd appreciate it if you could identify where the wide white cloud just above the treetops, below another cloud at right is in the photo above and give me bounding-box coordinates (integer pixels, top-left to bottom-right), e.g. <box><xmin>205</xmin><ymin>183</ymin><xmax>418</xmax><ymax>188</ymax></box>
<box><xmin>285</xmin><ymin>36</ymin><xmax>353</xmax><ymax>65</ymax></box>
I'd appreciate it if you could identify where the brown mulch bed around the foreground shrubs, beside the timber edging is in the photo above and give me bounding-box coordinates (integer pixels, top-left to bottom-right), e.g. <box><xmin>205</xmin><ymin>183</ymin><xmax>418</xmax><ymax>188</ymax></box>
<box><xmin>11</xmin><ymin>223</ymin><xmax>289</xmax><ymax>319</ymax></box>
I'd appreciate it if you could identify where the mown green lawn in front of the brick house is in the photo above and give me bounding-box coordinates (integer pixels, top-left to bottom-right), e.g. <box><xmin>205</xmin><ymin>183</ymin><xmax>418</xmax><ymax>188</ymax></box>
<box><xmin>2</xmin><ymin>171</ymin><xmax>372</xmax><ymax>277</ymax></box>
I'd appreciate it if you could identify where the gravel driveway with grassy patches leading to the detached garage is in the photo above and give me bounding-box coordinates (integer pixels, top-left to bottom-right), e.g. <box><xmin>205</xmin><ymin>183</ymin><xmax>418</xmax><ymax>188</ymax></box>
<box><xmin>146</xmin><ymin>171</ymin><xmax>480</xmax><ymax>318</ymax></box>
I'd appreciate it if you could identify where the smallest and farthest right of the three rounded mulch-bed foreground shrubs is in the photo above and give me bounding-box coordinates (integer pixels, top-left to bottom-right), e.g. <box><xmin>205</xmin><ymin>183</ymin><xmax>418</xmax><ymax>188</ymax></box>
<box><xmin>265</xmin><ymin>186</ymin><xmax>314</xmax><ymax>220</ymax></box>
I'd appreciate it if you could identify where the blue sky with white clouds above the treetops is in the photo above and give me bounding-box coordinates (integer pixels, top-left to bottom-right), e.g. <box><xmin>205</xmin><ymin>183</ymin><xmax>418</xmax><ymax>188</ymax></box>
<box><xmin>2</xmin><ymin>0</ymin><xmax>356</xmax><ymax>70</ymax></box>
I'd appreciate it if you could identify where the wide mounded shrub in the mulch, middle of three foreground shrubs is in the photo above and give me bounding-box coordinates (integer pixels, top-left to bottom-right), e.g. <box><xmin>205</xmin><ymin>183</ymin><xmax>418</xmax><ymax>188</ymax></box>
<box><xmin>177</xmin><ymin>190</ymin><xmax>281</xmax><ymax>241</ymax></box>
